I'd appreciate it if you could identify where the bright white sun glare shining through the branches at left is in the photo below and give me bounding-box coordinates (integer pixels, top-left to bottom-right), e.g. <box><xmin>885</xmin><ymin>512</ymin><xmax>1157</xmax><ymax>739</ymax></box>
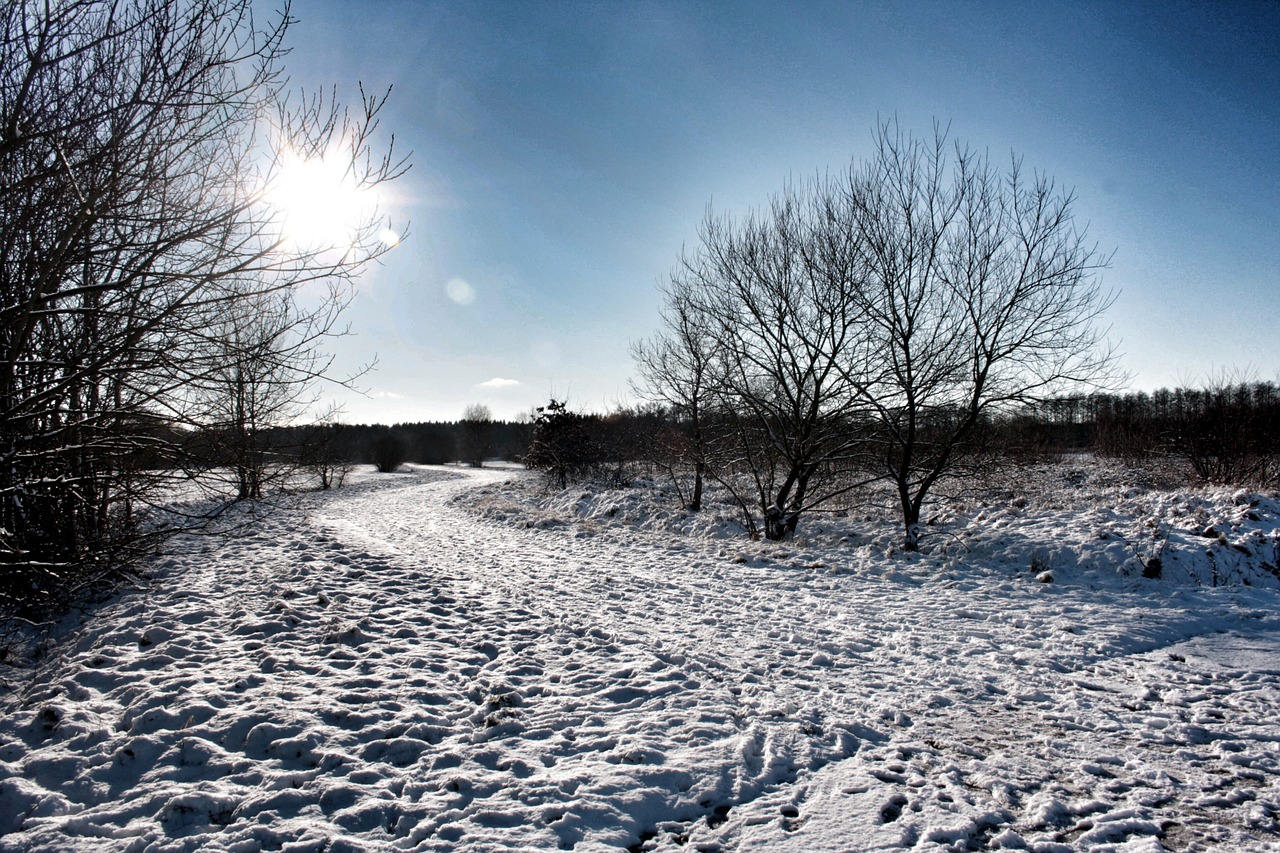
<box><xmin>266</xmin><ymin>155</ymin><xmax>373</xmax><ymax>248</ymax></box>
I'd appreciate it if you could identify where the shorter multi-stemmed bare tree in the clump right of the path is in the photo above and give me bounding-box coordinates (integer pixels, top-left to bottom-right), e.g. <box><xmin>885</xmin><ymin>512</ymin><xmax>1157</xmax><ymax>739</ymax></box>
<box><xmin>668</xmin><ymin>189</ymin><xmax>880</xmax><ymax>539</ymax></box>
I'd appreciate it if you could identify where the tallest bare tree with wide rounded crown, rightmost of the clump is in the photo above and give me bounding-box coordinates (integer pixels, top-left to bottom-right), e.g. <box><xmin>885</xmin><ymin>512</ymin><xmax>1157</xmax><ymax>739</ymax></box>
<box><xmin>828</xmin><ymin>123</ymin><xmax>1114</xmax><ymax>549</ymax></box>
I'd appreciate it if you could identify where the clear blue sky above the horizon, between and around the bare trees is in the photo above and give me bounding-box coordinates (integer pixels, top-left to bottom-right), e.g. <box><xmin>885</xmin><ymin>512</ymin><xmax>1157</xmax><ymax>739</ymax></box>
<box><xmin>287</xmin><ymin>0</ymin><xmax>1280</xmax><ymax>423</ymax></box>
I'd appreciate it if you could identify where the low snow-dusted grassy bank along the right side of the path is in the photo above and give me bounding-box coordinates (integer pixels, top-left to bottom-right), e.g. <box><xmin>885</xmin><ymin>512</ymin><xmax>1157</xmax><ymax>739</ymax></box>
<box><xmin>462</xmin><ymin>459</ymin><xmax>1280</xmax><ymax>589</ymax></box>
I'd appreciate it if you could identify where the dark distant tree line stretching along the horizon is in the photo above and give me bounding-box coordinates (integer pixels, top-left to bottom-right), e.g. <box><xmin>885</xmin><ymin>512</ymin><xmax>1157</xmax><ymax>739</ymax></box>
<box><xmin>217</xmin><ymin>373</ymin><xmax>1280</xmax><ymax>510</ymax></box>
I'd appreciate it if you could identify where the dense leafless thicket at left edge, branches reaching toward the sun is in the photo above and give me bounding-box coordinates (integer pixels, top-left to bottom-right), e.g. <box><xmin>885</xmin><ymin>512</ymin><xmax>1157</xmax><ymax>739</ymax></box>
<box><xmin>0</xmin><ymin>0</ymin><xmax>404</xmax><ymax>612</ymax></box>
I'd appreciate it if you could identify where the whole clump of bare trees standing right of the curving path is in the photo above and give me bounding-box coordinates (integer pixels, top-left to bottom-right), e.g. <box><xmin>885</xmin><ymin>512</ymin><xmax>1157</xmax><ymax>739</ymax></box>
<box><xmin>636</xmin><ymin>123</ymin><xmax>1112</xmax><ymax>540</ymax></box>
